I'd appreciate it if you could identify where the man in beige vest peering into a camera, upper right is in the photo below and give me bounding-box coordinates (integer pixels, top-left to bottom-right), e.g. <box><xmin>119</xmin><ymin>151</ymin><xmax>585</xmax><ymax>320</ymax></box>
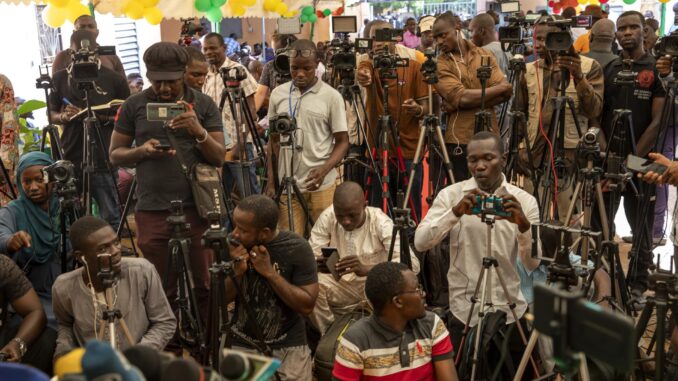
<box><xmin>514</xmin><ymin>16</ymin><xmax>604</xmax><ymax>223</ymax></box>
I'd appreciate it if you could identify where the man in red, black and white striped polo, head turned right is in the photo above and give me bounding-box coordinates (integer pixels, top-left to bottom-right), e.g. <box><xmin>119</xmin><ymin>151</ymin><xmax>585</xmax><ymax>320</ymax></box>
<box><xmin>332</xmin><ymin>262</ymin><xmax>458</xmax><ymax>381</ymax></box>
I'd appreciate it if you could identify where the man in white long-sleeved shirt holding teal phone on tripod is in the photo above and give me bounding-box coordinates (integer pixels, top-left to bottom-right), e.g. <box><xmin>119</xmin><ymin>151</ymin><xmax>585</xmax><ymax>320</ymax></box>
<box><xmin>414</xmin><ymin>132</ymin><xmax>539</xmax><ymax>368</ymax></box>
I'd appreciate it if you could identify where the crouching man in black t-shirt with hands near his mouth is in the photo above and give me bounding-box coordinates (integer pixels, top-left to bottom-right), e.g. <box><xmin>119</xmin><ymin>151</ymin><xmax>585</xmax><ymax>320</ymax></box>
<box><xmin>226</xmin><ymin>195</ymin><xmax>318</xmax><ymax>381</ymax></box>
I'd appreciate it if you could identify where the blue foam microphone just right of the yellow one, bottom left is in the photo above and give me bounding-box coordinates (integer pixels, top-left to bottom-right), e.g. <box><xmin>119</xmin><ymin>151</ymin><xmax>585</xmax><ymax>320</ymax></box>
<box><xmin>82</xmin><ymin>340</ymin><xmax>144</xmax><ymax>381</ymax></box>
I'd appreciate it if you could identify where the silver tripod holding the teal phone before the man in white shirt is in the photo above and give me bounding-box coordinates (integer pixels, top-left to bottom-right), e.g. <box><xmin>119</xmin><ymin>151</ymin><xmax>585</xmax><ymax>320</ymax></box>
<box><xmin>455</xmin><ymin>209</ymin><xmax>539</xmax><ymax>381</ymax></box>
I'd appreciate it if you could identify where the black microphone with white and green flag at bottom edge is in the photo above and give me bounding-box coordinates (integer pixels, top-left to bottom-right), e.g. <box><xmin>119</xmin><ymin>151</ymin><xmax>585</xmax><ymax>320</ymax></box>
<box><xmin>219</xmin><ymin>349</ymin><xmax>280</xmax><ymax>381</ymax></box>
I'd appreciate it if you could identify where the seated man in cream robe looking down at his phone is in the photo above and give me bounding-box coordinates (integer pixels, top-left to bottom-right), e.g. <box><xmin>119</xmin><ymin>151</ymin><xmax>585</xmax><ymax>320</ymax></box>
<box><xmin>309</xmin><ymin>181</ymin><xmax>419</xmax><ymax>334</ymax></box>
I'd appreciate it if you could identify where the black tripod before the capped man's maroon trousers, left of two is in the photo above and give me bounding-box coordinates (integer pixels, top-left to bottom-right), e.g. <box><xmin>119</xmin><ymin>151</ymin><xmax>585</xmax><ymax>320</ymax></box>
<box><xmin>164</xmin><ymin>200</ymin><xmax>205</xmax><ymax>353</ymax></box>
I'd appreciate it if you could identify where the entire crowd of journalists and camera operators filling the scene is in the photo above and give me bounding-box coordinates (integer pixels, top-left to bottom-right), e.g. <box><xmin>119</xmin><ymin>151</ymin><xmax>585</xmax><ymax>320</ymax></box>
<box><xmin>0</xmin><ymin>6</ymin><xmax>678</xmax><ymax>380</ymax></box>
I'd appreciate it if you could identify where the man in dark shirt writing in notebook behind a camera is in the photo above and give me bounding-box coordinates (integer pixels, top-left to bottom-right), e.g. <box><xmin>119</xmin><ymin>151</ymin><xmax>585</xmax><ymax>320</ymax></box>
<box><xmin>49</xmin><ymin>29</ymin><xmax>130</xmax><ymax>229</ymax></box>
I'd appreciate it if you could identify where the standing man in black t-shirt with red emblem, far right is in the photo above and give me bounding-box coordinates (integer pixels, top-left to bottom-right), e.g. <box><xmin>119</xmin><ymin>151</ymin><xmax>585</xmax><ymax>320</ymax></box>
<box><xmin>594</xmin><ymin>11</ymin><xmax>666</xmax><ymax>297</ymax></box>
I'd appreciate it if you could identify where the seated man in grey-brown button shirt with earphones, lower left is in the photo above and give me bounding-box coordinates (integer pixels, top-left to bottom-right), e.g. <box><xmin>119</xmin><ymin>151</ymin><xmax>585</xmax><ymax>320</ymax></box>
<box><xmin>52</xmin><ymin>216</ymin><xmax>177</xmax><ymax>358</ymax></box>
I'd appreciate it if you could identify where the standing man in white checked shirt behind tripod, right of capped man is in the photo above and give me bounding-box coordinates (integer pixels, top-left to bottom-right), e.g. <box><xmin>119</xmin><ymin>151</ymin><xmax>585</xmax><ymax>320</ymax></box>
<box><xmin>202</xmin><ymin>33</ymin><xmax>259</xmax><ymax>195</ymax></box>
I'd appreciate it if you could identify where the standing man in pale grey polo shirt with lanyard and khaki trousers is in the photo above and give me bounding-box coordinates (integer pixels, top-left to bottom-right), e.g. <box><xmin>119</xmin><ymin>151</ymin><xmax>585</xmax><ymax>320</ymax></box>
<box><xmin>266</xmin><ymin>40</ymin><xmax>348</xmax><ymax>235</ymax></box>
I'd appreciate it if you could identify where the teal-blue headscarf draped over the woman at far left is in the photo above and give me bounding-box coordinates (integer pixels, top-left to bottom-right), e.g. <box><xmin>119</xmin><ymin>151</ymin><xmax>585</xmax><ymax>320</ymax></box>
<box><xmin>7</xmin><ymin>152</ymin><xmax>61</xmax><ymax>263</ymax></box>
